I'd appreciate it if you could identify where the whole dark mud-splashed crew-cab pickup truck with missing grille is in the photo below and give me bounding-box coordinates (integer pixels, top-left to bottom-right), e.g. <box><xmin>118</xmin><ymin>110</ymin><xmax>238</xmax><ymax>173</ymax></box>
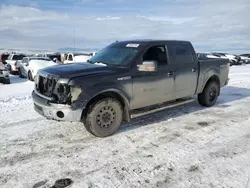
<box><xmin>32</xmin><ymin>40</ymin><xmax>230</xmax><ymax>137</ymax></box>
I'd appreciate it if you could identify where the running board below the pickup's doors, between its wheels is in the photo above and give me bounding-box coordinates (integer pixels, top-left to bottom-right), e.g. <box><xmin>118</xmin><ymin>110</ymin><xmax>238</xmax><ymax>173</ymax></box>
<box><xmin>131</xmin><ymin>98</ymin><xmax>195</xmax><ymax>119</ymax></box>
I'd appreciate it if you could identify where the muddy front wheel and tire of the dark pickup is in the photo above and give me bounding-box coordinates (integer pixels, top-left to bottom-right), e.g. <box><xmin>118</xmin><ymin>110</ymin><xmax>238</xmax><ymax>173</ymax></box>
<box><xmin>84</xmin><ymin>98</ymin><xmax>123</xmax><ymax>137</ymax></box>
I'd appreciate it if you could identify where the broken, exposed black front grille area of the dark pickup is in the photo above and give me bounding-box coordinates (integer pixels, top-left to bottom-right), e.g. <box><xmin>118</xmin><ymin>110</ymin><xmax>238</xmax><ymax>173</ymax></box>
<box><xmin>36</xmin><ymin>75</ymin><xmax>58</xmax><ymax>97</ymax></box>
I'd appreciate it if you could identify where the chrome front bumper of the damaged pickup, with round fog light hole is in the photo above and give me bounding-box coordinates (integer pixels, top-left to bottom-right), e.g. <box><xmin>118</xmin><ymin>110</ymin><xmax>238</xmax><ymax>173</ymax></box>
<box><xmin>32</xmin><ymin>91</ymin><xmax>82</xmax><ymax>122</ymax></box>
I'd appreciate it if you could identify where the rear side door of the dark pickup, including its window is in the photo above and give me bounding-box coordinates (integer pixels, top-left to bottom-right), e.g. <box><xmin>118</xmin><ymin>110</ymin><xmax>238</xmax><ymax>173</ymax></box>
<box><xmin>168</xmin><ymin>42</ymin><xmax>199</xmax><ymax>99</ymax></box>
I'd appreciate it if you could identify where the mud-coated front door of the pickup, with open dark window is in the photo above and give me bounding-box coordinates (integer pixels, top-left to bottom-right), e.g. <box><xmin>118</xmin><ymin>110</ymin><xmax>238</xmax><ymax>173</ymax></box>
<box><xmin>132</xmin><ymin>45</ymin><xmax>174</xmax><ymax>109</ymax></box>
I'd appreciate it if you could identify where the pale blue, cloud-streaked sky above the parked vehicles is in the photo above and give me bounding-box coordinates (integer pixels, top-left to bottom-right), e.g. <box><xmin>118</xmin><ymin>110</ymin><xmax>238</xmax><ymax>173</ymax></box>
<box><xmin>0</xmin><ymin>0</ymin><xmax>250</xmax><ymax>53</ymax></box>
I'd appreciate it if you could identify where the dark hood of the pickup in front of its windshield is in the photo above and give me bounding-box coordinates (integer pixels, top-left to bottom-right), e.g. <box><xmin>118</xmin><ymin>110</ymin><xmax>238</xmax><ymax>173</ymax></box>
<box><xmin>39</xmin><ymin>62</ymin><xmax>122</xmax><ymax>79</ymax></box>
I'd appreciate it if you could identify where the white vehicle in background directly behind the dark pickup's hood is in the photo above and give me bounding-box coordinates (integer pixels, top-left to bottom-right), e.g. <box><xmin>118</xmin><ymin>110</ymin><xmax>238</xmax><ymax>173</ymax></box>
<box><xmin>63</xmin><ymin>53</ymin><xmax>95</xmax><ymax>64</ymax></box>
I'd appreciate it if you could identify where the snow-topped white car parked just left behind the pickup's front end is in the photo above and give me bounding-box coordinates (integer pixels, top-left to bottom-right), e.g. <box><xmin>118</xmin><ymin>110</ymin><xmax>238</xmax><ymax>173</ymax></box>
<box><xmin>17</xmin><ymin>57</ymin><xmax>57</xmax><ymax>81</ymax></box>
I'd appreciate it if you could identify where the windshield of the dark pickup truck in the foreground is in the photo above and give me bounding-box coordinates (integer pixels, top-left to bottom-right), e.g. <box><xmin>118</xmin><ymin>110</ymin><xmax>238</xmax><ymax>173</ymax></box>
<box><xmin>88</xmin><ymin>47</ymin><xmax>138</xmax><ymax>66</ymax></box>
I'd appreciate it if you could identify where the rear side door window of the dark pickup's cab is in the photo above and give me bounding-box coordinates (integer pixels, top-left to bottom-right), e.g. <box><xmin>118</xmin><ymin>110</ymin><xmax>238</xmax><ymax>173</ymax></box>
<box><xmin>169</xmin><ymin>43</ymin><xmax>194</xmax><ymax>64</ymax></box>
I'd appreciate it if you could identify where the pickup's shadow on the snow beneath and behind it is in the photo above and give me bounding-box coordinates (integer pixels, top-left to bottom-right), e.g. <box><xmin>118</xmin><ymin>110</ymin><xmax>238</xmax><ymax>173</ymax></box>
<box><xmin>118</xmin><ymin>86</ymin><xmax>250</xmax><ymax>134</ymax></box>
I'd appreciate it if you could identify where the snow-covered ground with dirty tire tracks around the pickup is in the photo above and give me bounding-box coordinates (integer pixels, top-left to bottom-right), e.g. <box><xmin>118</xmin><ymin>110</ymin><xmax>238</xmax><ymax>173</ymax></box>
<box><xmin>0</xmin><ymin>66</ymin><xmax>250</xmax><ymax>188</ymax></box>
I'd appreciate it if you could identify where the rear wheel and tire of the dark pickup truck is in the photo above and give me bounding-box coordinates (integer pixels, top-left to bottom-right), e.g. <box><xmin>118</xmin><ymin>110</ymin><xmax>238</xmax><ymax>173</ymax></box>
<box><xmin>198</xmin><ymin>81</ymin><xmax>220</xmax><ymax>107</ymax></box>
